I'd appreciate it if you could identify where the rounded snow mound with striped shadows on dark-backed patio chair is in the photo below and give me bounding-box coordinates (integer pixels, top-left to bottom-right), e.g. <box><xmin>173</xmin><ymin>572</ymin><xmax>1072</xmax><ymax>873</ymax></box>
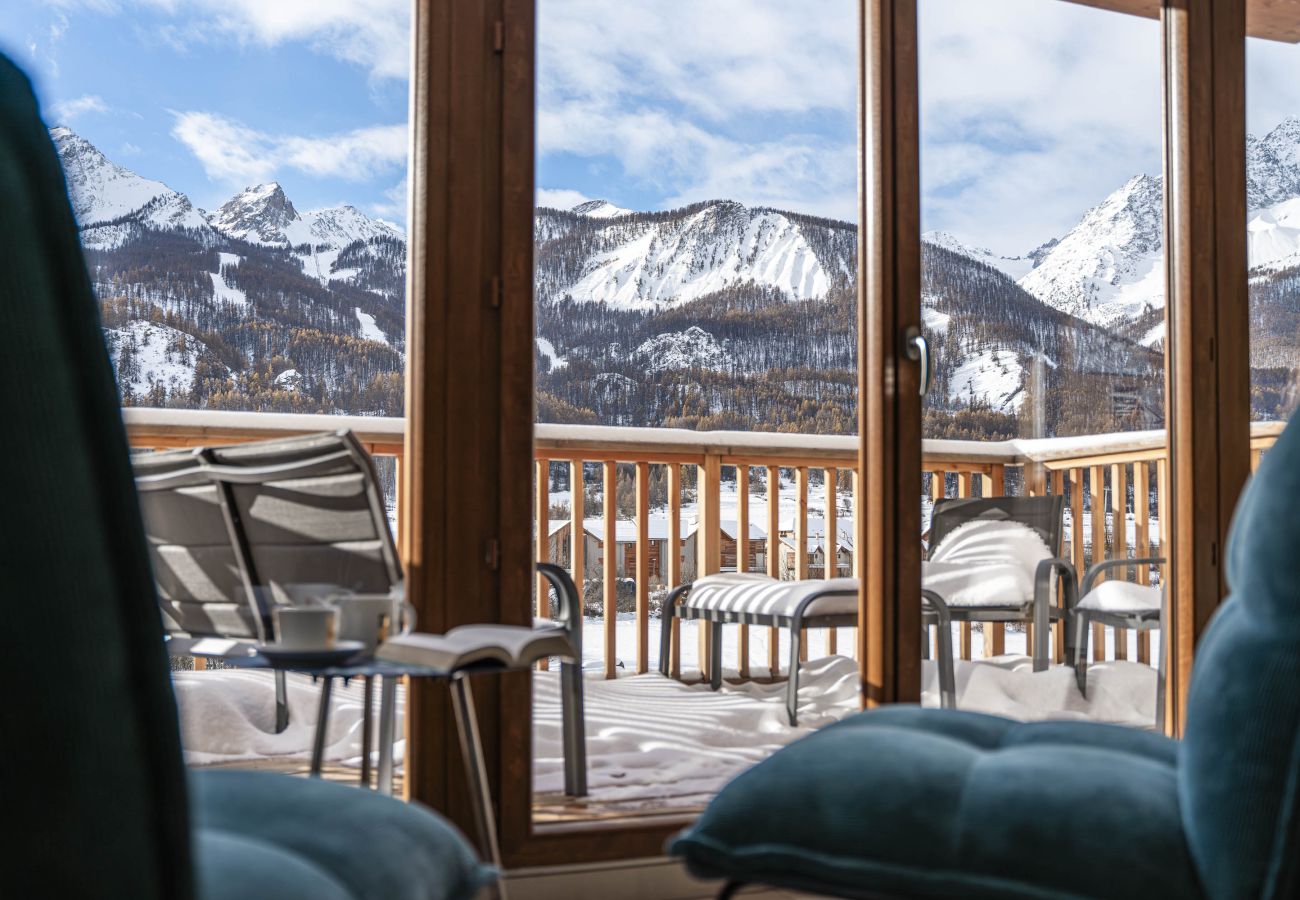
<box><xmin>920</xmin><ymin>519</ymin><xmax>1052</xmax><ymax>607</ymax></box>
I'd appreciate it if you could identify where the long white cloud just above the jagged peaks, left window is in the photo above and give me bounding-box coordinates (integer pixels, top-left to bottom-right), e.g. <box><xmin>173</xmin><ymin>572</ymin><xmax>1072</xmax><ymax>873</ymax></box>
<box><xmin>172</xmin><ymin>112</ymin><xmax>407</xmax><ymax>187</ymax></box>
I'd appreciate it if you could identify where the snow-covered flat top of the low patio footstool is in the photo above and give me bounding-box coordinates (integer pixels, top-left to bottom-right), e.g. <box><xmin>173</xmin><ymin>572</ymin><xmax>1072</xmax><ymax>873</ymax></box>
<box><xmin>683</xmin><ymin>572</ymin><xmax>858</xmax><ymax>616</ymax></box>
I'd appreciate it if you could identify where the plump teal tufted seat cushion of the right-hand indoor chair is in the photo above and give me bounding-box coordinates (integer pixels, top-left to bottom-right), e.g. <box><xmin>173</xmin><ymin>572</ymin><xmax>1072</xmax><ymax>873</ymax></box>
<box><xmin>670</xmin><ymin>706</ymin><xmax>1201</xmax><ymax>900</ymax></box>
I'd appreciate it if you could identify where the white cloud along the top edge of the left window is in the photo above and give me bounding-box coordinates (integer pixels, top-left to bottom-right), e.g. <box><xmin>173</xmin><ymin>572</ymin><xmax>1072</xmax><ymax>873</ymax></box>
<box><xmin>53</xmin><ymin>0</ymin><xmax>411</xmax><ymax>79</ymax></box>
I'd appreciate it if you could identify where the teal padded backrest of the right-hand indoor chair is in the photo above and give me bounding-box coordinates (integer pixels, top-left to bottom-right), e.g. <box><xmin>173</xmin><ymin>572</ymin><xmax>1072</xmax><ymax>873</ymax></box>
<box><xmin>1179</xmin><ymin>423</ymin><xmax>1300</xmax><ymax>897</ymax></box>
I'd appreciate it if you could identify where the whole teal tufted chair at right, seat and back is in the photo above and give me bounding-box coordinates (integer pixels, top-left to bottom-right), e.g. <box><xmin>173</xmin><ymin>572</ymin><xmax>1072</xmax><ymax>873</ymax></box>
<box><xmin>670</xmin><ymin>421</ymin><xmax>1300</xmax><ymax>900</ymax></box>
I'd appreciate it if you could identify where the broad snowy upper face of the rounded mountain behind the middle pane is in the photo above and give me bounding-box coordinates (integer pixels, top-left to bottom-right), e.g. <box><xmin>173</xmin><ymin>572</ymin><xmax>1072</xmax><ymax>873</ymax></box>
<box><xmin>537</xmin><ymin>200</ymin><xmax>854</xmax><ymax>310</ymax></box>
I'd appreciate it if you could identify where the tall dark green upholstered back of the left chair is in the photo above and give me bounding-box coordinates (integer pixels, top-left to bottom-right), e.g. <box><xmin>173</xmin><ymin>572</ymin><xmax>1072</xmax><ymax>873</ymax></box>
<box><xmin>0</xmin><ymin>56</ymin><xmax>192</xmax><ymax>899</ymax></box>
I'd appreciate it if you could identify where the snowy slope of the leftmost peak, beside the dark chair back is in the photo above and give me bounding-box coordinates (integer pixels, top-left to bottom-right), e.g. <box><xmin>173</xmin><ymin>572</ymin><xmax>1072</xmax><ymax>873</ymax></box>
<box><xmin>49</xmin><ymin>127</ymin><xmax>207</xmax><ymax>245</ymax></box>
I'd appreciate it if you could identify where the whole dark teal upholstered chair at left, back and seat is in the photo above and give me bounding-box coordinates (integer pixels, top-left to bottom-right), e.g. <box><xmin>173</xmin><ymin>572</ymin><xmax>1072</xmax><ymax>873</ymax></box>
<box><xmin>0</xmin><ymin>56</ymin><xmax>493</xmax><ymax>900</ymax></box>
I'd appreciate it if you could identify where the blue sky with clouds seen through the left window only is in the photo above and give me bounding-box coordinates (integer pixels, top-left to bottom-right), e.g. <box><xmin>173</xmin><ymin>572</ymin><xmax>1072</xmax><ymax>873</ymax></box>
<box><xmin>0</xmin><ymin>0</ymin><xmax>410</xmax><ymax>222</ymax></box>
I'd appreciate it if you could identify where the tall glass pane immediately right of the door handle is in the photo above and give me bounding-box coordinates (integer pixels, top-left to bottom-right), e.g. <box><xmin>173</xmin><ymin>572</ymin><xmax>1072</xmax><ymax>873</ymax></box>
<box><xmin>920</xmin><ymin>0</ymin><xmax>1165</xmax><ymax>727</ymax></box>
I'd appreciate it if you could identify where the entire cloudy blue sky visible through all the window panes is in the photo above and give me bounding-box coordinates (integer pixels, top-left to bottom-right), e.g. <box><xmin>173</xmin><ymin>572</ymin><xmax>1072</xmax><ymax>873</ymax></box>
<box><xmin>0</xmin><ymin>0</ymin><xmax>1300</xmax><ymax>255</ymax></box>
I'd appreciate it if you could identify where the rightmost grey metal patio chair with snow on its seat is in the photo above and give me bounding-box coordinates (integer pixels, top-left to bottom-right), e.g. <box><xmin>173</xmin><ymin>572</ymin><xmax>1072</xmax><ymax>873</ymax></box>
<box><xmin>1074</xmin><ymin>557</ymin><xmax>1167</xmax><ymax>726</ymax></box>
